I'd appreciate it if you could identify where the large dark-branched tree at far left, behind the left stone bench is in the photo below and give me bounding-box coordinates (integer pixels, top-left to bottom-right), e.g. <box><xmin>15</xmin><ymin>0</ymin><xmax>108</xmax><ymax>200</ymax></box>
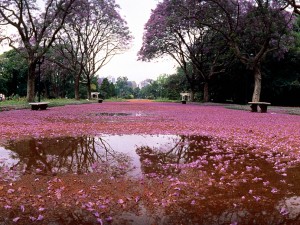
<box><xmin>0</xmin><ymin>0</ymin><xmax>79</xmax><ymax>101</ymax></box>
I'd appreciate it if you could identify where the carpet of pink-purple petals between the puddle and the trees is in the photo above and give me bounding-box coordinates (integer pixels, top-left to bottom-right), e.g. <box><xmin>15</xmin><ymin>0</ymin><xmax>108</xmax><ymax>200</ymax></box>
<box><xmin>0</xmin><ymin>102</ymin><xmax>300</xmax><ymax>154</ymax></box>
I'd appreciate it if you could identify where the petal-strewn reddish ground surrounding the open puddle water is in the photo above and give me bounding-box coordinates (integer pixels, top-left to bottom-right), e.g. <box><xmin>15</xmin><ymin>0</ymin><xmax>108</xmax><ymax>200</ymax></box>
<box><xmin>0</xmin><ymin>101</ymin><xmax>300</xmax><ymax>224</ymax></box>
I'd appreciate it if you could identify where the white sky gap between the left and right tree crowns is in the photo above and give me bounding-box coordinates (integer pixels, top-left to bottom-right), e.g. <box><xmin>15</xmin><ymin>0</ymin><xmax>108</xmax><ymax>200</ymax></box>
<box><xmin>98</xmin><ymin>0</ymin><xmax>176</xmax><ymax>83</ymax></box>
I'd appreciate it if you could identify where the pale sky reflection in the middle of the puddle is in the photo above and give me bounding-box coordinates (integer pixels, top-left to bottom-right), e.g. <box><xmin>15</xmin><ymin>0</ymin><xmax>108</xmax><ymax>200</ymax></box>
<box><xmin>96</xmin><ymin>135</ymin><xmax>179</xmax><ymax>175</ymax></box>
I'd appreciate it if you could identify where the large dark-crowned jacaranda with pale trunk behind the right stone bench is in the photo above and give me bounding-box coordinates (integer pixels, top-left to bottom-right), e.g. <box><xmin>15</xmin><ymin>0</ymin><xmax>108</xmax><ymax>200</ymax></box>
<box><xmin>198</xmin><ymin>0</ymin><xmax>294</xmax><ymax>102</ymax></box>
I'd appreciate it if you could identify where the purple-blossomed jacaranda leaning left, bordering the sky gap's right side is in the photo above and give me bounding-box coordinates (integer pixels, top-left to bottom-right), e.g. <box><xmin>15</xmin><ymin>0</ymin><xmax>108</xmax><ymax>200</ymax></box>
<box><xmin>138</xmin><ymin>0</ymin><xmax>199</xmax><ymax>100</ymax></box>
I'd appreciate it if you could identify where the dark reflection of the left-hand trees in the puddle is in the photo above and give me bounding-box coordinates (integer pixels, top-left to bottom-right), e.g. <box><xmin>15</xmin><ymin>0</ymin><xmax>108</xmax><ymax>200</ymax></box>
<box><xmin>5</xmin><ymin>136</ymin><xmax>131</xmax><ymax>176</ymax></box>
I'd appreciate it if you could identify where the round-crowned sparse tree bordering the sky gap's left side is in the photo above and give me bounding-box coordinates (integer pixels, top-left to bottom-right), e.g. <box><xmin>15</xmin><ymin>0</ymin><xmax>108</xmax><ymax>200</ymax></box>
<box><xmin>57</xmin><ymin>0</ymin><xmax>132</xmax><ymax>98</ymax></box>
